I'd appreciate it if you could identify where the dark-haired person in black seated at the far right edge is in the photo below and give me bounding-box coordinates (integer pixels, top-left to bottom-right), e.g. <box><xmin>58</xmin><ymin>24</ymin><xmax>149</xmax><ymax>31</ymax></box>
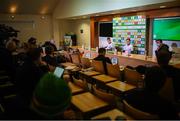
<box><xmin>156</xmin><ymin>50</ymin><xmax>180</xmax><ymax>100</ymax></box>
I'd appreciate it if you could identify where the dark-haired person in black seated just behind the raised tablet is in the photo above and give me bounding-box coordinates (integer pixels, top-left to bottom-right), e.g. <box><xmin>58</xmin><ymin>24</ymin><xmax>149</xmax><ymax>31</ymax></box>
<box><xmin>42</xmin><ymin>45</ymin><xmax>58</xmax><ymax>66</ymax></box>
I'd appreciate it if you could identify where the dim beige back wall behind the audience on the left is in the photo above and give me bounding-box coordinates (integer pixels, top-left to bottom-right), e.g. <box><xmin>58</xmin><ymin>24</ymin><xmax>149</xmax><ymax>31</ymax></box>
<box><xmin>0</xmin><ymin>14</ymin><xmax>53</xmax><ymax>42</ymax></box>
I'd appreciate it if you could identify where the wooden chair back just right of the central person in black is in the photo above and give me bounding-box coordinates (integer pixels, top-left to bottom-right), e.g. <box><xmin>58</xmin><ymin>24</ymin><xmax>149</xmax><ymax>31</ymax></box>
<box><xmin>106</xmin><ymin>63</ymin><xmax>120</xmax><ymax>79</ymax></box>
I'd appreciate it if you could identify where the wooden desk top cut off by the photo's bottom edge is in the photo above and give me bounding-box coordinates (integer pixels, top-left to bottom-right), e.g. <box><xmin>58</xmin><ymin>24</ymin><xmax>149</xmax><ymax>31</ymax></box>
<box><xmin>91</xmin><ymin>109</ymin><xmax>132</xmax><ymax>120</ymax></box>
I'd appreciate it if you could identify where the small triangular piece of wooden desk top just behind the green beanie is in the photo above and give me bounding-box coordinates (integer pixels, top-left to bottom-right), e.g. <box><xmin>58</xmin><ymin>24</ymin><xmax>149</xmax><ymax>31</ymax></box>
<box><xmin>68</xmin><ymin>82</ymin><xmax>84</xmax><ymax>95</ymax></box>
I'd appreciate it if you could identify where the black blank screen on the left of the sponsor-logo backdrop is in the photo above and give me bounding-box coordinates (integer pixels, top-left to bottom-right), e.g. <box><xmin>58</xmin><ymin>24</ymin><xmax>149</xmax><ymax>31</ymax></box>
<box><xmin>99</xmin><ymin>22</ymin><xmax>113</xmax><ymax>37</ymax></box>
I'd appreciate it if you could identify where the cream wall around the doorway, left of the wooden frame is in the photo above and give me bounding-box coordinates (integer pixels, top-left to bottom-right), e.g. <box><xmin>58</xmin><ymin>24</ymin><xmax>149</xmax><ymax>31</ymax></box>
<box><xmin>59</xmin><ymin>19</ymin><xmax>90</xmax><ymax>47</ymax></box>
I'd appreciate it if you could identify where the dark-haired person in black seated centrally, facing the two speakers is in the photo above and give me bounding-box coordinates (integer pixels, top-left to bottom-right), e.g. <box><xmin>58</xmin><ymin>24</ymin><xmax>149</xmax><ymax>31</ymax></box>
<box><xmin>94</xmin><ymin>48</ymin><xmax>112</xmax><ymax>74</ymax></box>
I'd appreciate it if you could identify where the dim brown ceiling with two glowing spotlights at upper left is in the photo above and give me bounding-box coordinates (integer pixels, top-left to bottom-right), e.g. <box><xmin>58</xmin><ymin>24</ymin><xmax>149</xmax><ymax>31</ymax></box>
<box><xmin>0</xmin><ymin>0</ymin><xmax>60</xmax><ymax>14</ymax></box>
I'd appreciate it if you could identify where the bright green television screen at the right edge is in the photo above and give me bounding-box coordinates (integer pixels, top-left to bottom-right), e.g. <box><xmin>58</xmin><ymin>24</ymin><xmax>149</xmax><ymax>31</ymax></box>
<box><xmin>153</xmin><ymin>17</ymin><xmax>180</xmax><ymax>41</ymax></box>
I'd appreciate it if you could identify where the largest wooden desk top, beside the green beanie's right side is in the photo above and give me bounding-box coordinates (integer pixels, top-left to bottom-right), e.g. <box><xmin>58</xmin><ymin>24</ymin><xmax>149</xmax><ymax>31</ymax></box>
<box><xmin>71</xmin><ymin>92</ymin><xmax>108</xmax><ymax>113</ymax></box>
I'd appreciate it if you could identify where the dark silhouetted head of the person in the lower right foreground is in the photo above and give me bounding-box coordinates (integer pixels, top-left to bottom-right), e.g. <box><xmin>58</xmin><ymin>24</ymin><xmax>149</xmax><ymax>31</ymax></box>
<box><xmin>144</xmin><ymin>66</ymin><xmax>166</xmax><ymax>93</ymax></box>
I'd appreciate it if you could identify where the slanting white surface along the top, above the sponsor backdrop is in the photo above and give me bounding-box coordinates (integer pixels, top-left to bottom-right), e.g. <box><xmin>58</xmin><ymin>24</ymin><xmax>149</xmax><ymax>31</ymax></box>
<box><xmin>53</xmin><ymin>0</ymin><xmax>175</xmax><ymax>19</ymax></box>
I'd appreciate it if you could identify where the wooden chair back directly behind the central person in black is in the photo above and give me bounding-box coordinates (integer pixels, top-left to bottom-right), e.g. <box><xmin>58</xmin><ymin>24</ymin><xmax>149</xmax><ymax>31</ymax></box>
<box><xmin>91</xmin><ymin>60</ymin><xmax>105</xmax><ymax>74</ymax></box>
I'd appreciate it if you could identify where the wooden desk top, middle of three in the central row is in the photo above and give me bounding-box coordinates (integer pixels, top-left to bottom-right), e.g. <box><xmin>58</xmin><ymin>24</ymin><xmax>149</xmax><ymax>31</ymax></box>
<box><xmin>92</xmin><ymin>74</ymin><xmax>117</xmax><ymax>83</ymax></box>
